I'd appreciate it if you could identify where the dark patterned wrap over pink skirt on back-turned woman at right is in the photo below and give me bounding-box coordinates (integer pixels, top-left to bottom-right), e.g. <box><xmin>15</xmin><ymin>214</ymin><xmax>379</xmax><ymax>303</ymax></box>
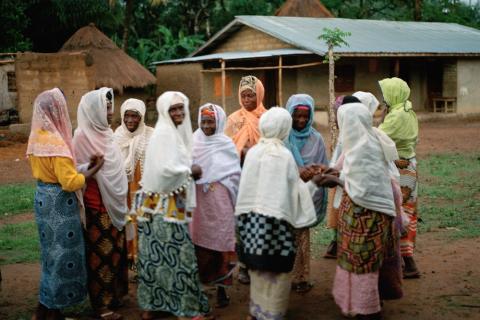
<box><xmin>333</xmin><ymin>193</ymin><xmax>393</xmax><ymax>315</ymax></box>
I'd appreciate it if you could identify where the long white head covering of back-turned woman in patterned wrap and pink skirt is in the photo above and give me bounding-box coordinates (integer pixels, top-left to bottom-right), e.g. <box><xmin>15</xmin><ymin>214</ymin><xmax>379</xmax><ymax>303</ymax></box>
<box><xmin>338</xmin><ymin>103</ymin><xmax>398</xmax><ymax>216</ymax></box>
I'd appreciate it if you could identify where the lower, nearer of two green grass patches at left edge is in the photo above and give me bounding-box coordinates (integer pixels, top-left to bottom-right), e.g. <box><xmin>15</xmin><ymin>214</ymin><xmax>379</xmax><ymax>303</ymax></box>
<box><xmin>0</xmin><ymin>221</ymin><xmax>40</xmax><ymax>264</ymax></box>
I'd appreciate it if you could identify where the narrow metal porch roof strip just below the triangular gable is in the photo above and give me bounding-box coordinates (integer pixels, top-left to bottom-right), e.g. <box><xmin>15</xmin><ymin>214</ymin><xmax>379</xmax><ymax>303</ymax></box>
<box><xmin>152</xmin><ymin>49</ymin><xmax>312</xmax><ymax>65</ymax></box>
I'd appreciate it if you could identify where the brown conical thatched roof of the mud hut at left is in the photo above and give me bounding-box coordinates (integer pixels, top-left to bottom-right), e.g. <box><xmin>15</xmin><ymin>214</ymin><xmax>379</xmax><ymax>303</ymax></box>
<box><xmin>60</xmin><ymin>23</ymin><xmax>156</xmax><ymax>93</ymax></box>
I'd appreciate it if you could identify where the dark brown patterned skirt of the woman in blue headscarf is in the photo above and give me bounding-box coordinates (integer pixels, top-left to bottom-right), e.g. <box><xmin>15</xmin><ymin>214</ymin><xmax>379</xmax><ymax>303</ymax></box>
<box><xmin>292</xmin><ymin>229</ymin><xmax>310</xmax><ymax>283</ymax></box>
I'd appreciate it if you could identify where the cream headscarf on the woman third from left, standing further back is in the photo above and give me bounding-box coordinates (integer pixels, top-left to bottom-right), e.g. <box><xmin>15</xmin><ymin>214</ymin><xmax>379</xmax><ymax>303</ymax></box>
<box><xmin>114</xmin><ymin>98</ymin><xmax>153</xmax><ymax>181</ymax></box>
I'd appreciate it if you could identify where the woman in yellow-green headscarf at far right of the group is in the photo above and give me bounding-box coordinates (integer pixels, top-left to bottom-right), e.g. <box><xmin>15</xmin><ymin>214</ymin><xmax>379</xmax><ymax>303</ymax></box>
<box><xmin>379</xmin><ymin>78</ymin><xmax>420</xmax><ymax>278</ymax></box>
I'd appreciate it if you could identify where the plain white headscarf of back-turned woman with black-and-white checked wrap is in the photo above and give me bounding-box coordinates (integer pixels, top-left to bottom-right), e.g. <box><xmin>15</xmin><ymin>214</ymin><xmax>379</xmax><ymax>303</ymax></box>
<box><xmin>235</xmin><ymin>107</ymin><xmax>316</xmax><ymax>228</ymax></box>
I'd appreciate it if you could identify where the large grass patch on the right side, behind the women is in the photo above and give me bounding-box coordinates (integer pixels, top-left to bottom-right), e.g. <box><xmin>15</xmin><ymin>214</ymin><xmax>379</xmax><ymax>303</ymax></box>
<box><xmin>418</xmin><ymin>153</ymin><xmax>480</xmax><ymax>238</ymax></box>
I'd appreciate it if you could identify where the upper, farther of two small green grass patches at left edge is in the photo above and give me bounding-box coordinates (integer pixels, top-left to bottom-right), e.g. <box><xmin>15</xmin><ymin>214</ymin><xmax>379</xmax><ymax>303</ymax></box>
<box><xmin>0</xmin><ymin>183</ymin><xmax>35</xmax><ymax>218</ymax></box>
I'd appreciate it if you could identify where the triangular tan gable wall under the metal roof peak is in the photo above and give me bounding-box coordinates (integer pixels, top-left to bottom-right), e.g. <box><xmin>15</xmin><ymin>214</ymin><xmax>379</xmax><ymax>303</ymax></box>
<box><xmin>212</xmin><ymin>26</ymin><xmax>294</xmax><ymax>53</ymax></box>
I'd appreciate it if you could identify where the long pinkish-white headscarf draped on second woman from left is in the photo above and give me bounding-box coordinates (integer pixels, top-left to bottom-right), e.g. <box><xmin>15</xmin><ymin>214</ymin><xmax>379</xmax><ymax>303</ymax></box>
<box><xmin>73</xmin><ymin>88</ymin><xmax>128</xmax><ymax>230</ymax></box>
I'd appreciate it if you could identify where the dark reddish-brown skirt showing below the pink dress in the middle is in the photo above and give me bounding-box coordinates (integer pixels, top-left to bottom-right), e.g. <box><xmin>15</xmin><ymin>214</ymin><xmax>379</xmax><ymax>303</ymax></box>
<box><xmin>195</xmin><ymin>246</ymin><xmax>236</xmax><ymax>287</ymax></box>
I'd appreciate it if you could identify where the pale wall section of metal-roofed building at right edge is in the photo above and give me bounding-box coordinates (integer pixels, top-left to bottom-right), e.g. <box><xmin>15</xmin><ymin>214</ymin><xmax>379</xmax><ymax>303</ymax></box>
<box><xmin>457</xmin><ymin>59</ymin><xmax>480</xmax><ymax>113</ymax></box>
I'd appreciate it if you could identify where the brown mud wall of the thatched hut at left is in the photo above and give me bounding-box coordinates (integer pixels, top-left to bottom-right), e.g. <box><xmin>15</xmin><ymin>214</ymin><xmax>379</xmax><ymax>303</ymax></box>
<box><xmin>15</xmin><ymin>52</ymin><xmax>95</xmax><ymax>123</ymax></box>
